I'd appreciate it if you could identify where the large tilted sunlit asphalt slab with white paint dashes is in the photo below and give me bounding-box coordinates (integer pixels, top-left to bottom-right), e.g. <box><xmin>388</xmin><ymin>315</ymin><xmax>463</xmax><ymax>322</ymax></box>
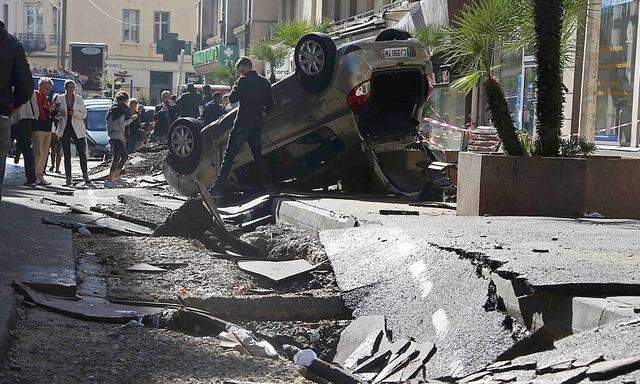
<box><xmin>320</xmin><ymin>225</ymin><xmax>513</xmax><ymax>377</ymax></box>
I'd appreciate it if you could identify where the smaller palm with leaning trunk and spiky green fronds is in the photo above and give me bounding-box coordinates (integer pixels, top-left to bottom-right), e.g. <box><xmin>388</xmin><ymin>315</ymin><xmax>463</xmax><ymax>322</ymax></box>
<box><xmin>441</xmin><ymin>0</ymin><xmax>525</xmax><ymax>156</ymax></box>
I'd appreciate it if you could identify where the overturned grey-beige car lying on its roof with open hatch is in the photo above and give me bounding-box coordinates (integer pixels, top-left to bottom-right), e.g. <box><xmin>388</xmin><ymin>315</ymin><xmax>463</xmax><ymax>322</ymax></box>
<box><xmin>164</xmin><ymin>29</ymin><xmax>432</xmax><ymax>195</ymax></box>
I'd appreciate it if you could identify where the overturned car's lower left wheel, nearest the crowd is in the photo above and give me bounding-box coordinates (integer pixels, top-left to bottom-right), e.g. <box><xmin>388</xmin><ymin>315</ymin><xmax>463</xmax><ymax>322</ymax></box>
<box><xmin>167</xmin><ymin>117</ymin><xmax>202</xmax><ymax>175</ymax></box>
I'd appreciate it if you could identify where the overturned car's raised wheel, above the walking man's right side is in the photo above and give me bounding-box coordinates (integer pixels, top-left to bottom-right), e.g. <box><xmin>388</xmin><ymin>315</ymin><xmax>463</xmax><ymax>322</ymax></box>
<box><xmin>294</xmin><ymin>33</ymin><xmax>336</xmax><ymax>93</ymax></box>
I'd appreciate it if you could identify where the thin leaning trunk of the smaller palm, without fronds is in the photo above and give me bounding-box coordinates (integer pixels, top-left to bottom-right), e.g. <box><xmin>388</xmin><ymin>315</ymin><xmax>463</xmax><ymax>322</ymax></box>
<box><xmin>484</xmin><ymin>77</ymin><xmax>525</xmax><ymax>156</ymax></box>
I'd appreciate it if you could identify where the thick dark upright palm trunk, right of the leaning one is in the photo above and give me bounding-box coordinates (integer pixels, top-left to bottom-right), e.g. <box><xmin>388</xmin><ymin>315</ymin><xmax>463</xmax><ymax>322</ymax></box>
<box><xmin>534</xmin><ymin>0</ymin><xmax>564</xmax><ymax>156</ymax></box>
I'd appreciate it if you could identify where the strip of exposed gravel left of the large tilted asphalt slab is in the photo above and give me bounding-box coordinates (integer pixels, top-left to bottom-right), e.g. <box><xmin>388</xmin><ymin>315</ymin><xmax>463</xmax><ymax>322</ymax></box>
<box><xmin>74</xmin><ymin>235</ymin><xmax>339</xmax><ymax>302</ymax></box>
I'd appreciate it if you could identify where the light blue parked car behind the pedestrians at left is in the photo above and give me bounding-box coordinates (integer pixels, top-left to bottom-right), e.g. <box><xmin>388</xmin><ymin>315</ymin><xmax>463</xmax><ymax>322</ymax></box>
<box><xmin>84</xmin><ymin>99</ymin><xmax>112</xmax><ymax>157</ymax></box>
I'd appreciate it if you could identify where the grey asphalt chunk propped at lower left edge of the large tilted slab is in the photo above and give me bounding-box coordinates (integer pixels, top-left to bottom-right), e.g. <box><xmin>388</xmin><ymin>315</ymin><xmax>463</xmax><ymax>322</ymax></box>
<box><xmin>333</xmin><ymin>316</ymin><xmax>387</xmax><ymax>368</ymax></box>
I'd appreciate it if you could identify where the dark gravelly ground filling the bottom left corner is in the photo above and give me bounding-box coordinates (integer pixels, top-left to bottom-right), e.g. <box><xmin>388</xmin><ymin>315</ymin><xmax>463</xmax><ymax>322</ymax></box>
<box><xmin>0</xmin><ymin>307</ymin><xmax>309</xmax><ymax>384</ymax></box>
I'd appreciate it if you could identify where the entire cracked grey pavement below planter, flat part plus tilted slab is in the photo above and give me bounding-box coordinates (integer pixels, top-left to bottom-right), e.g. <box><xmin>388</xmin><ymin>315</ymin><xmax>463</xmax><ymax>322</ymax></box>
<box><xmin>276</xmin><ymin>198</ymin><xmax>640</xmax><ymax>377</ymax></box>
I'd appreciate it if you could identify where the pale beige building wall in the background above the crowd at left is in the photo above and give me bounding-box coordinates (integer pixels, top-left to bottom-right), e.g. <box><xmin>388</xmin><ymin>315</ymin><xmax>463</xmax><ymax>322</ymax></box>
<box><xmin>8</xmin><ymin>0</ymin><xmax>198</xmax><ymax>102</ymax></box>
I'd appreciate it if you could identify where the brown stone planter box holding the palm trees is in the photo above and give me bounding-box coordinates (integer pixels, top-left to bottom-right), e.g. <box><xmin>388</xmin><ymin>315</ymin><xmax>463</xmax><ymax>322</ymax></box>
<box><xmin>457</xmin><ymin>152</ymin><xmax>640</xmax><ymax>219</ymax></box>
